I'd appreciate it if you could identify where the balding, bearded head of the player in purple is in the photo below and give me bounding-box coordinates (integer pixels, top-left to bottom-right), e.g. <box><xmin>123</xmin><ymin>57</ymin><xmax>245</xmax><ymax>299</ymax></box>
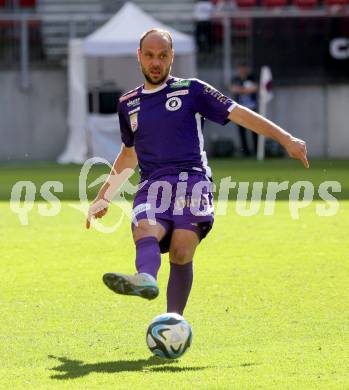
<box><xmin>138</xmin><ymin>33</ymin><xmax>173</xmax><ymax>85</ymax></box>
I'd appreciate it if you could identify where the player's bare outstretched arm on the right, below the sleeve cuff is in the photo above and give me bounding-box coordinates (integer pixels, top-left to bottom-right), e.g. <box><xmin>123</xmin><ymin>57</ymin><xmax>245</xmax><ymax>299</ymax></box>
<box><xmin>228</xmin><ymin>105</ymin><xmax>309</xmax><ymax>168</ymax></box>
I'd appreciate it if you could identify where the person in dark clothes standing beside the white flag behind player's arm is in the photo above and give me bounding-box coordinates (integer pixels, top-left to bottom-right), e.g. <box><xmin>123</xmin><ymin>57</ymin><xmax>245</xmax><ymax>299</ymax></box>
<box><xmin>230</xmin><ymin>62</ymin><xmax>258</xmax><ymax>157</ymax></box>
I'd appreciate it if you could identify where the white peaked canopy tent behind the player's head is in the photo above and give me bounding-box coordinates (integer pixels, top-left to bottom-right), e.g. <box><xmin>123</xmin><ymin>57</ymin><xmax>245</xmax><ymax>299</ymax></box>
<box><xmin>58</xmin><ymin>3</ymin><xmax>196</xmax><ymax>163</ymax></box>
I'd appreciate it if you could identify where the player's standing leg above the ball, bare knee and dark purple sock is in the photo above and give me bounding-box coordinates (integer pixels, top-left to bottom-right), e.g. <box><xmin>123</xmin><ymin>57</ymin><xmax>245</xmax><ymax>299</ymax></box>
<box><xmin>167</xmin><ymin>225</ymin><xmax>200</xmax><ymax>314</ymax></box>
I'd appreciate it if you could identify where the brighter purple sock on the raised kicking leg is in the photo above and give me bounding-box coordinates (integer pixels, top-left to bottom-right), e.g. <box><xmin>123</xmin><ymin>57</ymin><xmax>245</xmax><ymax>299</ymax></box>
<box><xmin>136</xmin><ymin>237</ymin><xmax>161</xmax><ymax>279</ymax></box>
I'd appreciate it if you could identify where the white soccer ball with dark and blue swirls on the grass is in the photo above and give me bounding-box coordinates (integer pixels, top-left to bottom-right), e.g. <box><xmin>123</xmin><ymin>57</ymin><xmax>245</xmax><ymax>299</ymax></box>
<box><xmin>146</xmin><ymin>313</ymin><xmax>192</xmax><ymax>359</ymax></box>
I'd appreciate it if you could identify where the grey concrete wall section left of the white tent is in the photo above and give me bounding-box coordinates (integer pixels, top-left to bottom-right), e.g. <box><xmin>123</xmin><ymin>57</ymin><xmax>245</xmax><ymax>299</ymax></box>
<box><xmin>0</xmin><ymin>70</ymin><xmax>67</xmax><ymax>161</ymax></box>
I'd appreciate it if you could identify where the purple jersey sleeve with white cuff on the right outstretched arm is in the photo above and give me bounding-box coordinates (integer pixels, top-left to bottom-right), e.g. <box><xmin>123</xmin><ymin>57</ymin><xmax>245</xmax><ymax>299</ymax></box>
<box><xmin>194</xmin><ymin>80</ymin><xmax>237</xmax><ymax>125</ymax></box>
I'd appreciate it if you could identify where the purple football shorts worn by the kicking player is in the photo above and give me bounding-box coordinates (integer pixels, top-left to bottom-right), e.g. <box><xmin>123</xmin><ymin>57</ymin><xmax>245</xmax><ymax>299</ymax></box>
<box><xmin>132</xmin><ymin>172</ymin><xmax>214</xmax><ymax>253</ymax></box>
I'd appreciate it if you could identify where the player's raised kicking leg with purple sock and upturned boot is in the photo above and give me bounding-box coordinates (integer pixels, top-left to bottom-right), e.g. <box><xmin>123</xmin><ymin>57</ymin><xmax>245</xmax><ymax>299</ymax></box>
<box><xmin>103</xmin><ymin>219</ymin><xmax>166</xmax><ymax>299</ymax></box>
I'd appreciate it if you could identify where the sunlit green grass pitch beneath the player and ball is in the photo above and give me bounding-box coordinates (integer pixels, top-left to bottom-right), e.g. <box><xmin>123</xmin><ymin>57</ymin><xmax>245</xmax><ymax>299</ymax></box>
<box><xmin>0</xmin><ymin>160</ymin><xmax>349</xmax><ymax>390</ymax></box>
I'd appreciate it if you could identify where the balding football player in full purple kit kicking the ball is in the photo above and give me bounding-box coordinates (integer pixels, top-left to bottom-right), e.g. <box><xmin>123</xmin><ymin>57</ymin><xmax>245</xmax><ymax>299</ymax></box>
<box><xmin>86</xmin><ymin>29</ymin><xmax>309</xmax><ymax>314</ymax></box>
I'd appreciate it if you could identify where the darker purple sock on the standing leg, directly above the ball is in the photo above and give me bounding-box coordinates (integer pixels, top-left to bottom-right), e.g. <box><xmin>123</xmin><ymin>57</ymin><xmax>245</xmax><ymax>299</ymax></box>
<box><xmin>167</xmin><ymin>261</ymin><xmax>193</xmax><ymax>315</ymax></box>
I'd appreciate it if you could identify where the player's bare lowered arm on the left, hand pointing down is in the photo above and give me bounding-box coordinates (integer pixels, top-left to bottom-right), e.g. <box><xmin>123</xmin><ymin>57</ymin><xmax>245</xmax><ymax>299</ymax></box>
<box><xmin>86</xmin><ymin>144</ymin><xmax>138</xmax><ymax>229</ymax></box>
